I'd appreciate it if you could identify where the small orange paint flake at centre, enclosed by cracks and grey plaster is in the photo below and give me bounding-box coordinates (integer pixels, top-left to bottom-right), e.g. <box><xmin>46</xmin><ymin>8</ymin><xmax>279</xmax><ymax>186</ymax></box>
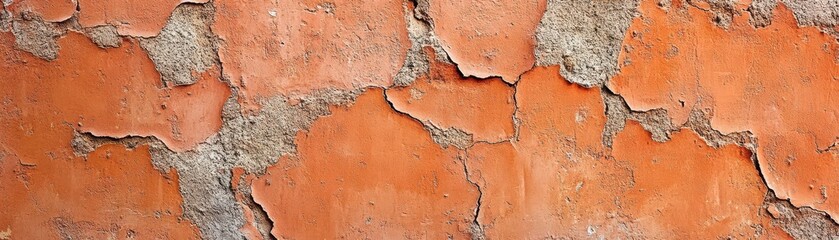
<box><xmin>387</xmin><ymin>49</ymin><xmax>516</xmax><ymax>142</ymax></box>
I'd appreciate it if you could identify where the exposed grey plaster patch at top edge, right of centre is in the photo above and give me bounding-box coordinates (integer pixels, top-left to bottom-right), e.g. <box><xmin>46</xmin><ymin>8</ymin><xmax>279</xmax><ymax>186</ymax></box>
<box><xmin>535</xmin><ymin>0</ymin><xmax>638</xmax><ymax>87</ymax></box>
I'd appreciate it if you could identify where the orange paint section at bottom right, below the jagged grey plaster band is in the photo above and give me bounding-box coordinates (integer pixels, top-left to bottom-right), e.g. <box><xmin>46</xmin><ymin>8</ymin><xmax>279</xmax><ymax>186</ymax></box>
<box><xmin>612</xmin><ymin>122</ymin><xmax>769</xmax><ymax>239</ymax></box>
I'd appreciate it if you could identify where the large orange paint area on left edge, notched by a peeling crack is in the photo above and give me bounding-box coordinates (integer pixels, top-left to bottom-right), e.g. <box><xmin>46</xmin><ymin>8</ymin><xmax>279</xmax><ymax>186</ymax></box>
<box><xmin>0</xmin><ymin>28</ymin><xmax>229</xmax><ymax>236</ymax></box>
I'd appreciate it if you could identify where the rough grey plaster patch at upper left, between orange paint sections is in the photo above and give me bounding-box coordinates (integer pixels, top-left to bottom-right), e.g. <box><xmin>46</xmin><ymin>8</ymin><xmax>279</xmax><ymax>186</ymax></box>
<box><xmin>140</xmin><ymin>3</ymin><xmax>218</xmax><ymax>85</ymax></box>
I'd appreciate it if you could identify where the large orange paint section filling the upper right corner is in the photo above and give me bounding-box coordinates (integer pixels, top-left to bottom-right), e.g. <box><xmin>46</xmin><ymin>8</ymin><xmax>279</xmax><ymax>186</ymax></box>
<box><xmin>609</xmin><ymin>1</ymin><xmax>839</xmax><ymax>219</ymax></box>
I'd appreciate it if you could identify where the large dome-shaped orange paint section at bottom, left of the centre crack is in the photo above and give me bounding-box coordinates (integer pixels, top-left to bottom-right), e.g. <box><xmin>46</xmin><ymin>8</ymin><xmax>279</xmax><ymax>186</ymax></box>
<box><xmin>253</xmin><ymin>90</ymin><xmax>478</xmax><ymax>239</ymax></box>
